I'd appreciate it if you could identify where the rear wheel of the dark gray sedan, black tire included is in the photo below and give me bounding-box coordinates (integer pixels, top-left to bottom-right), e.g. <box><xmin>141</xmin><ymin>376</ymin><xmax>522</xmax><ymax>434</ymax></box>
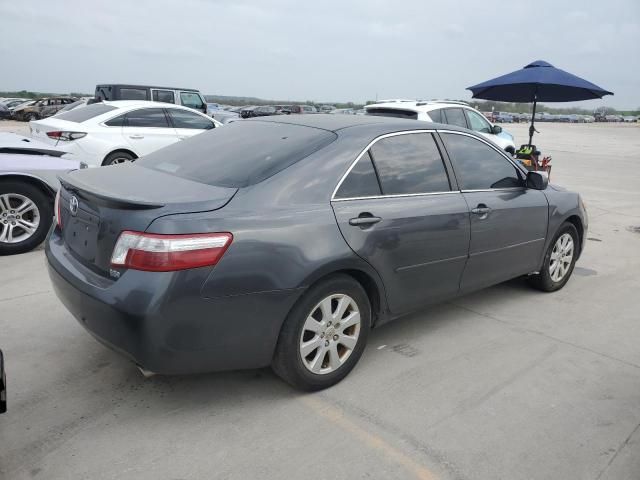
<box><xmin>272</xmin><ymin>275</ymin><xmax>371</xmax><ymax>391</ymax></box>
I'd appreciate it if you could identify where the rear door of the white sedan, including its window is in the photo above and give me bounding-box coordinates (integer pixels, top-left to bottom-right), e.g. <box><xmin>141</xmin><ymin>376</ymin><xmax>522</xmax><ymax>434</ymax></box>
<box><xmin>122</xmin><ymin>108</ymin><xmax>178</xmax><ymax>156</ymax></box>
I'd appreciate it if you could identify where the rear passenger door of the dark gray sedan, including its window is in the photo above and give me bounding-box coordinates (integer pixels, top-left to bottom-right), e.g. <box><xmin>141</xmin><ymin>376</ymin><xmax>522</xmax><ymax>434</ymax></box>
<box><xmin>332</xmin><ymin>131</ymin><xmax>469</xmax><ymax>314</ymax></box>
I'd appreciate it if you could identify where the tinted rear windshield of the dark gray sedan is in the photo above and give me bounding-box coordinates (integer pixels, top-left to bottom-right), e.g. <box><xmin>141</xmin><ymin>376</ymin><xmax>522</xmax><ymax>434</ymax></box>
<box><xmin>136</xmin><ymin>121</ymin><xmax>337</xmax><ymax>188</ymax></box>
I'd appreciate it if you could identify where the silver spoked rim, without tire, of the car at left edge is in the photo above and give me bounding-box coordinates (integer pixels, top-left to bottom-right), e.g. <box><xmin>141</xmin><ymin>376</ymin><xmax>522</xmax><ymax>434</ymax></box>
<box><xmin>0</xmin><ymin>193</ymin><xmax>40</xmax><ymax>243</ymax></box>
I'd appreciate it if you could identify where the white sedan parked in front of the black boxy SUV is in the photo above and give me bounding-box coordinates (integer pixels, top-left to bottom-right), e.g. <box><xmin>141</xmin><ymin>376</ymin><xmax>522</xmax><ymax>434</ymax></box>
<box><xmin>29</xmin><ymin>100</ymin><xmax>222</xmax><ymax>167</ymax></box>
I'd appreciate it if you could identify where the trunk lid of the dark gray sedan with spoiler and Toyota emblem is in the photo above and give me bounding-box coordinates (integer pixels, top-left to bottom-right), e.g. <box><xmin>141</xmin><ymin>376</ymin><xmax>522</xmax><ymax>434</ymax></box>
<box><xmin>59</xmin><ymin>164</ymin><xmax>237</xmax><ymax>276</ymax></box>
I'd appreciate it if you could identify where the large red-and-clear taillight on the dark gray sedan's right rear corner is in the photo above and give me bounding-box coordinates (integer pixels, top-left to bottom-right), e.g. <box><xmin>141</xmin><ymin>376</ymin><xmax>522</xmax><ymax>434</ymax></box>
<box><xmin>111</xmin><ymin>231</ymin><xmax>233</xmax><ymax>272</ymax></box>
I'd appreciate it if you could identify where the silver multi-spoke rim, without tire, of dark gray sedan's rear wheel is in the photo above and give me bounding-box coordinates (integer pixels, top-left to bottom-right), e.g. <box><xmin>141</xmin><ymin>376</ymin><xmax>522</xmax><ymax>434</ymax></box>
<box><xmin>299</xmin><ymin>294</ymin><xmax>361</xmax><ymax>375</ymax></box>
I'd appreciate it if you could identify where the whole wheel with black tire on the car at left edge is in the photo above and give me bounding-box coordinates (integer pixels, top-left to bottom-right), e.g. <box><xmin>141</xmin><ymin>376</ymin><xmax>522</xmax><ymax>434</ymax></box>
<box><xmin>0</xmin><ymin>180</ymin><xmax>53</xmax><ymax>255</ymax></box>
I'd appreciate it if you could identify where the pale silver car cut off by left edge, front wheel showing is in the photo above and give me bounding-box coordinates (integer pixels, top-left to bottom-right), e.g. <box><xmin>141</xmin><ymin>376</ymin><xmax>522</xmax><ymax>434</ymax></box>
<box><xmin>0</xmin><ymin>133</ymin><xmax>85</xmax><ymax>255</ymax></box>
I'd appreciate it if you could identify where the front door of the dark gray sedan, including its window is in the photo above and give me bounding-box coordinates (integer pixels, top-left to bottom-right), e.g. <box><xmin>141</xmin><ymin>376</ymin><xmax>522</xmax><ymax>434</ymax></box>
<box><xmin>440</xmin><ymin>132</ymin><xmax>549</xmax><ymax>292</ymax></box>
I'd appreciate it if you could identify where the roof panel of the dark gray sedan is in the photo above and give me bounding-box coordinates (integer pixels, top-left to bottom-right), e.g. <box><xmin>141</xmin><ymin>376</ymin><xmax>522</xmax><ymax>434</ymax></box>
<box><xmin>244</xmin><ymin>113</ymin><xmax>460</xmax><ymax>134</ymax></box>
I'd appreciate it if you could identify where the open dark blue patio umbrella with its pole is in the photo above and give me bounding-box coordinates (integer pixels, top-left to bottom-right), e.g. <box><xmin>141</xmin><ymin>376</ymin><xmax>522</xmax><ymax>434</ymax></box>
<box><xmin>467</xmin><ymin>60</ymin><xmax>613</xmax><ymax>145</ymax></box>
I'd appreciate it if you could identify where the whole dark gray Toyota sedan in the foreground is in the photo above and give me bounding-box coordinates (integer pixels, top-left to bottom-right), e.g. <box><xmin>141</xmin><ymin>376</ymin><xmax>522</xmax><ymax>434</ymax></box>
<box><xmin>46</xmin><ymin>115</ymin><xmax>587</xmax><ymax>390</ymax></box>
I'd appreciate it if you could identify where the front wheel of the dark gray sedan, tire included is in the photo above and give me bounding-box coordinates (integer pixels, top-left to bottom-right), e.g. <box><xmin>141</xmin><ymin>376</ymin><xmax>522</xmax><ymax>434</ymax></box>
<box><xmin>529</xmin><ymin>222</ymin><xmax>580</xmax><ymax>292</ymax></box>
